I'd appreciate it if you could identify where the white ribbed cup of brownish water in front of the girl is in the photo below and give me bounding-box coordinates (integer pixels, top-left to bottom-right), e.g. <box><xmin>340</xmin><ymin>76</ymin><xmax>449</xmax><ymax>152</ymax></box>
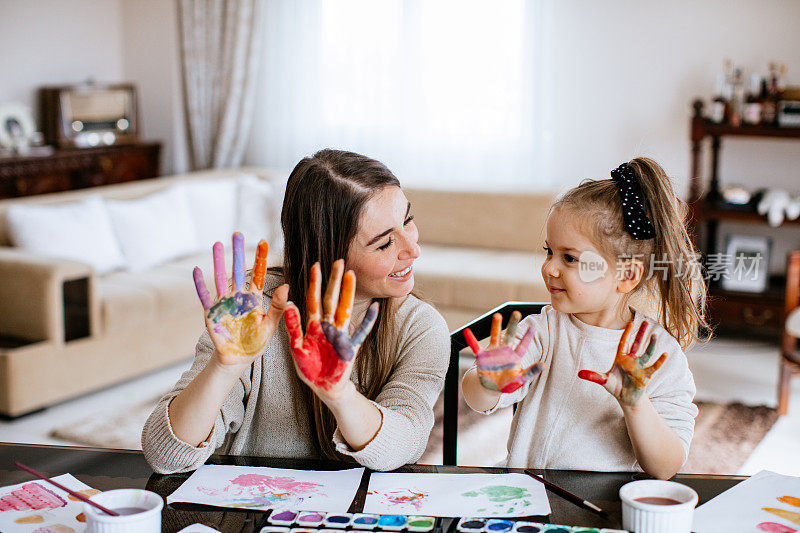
<box><xmin>619</xmin><ymin>479</ymin><xmax>698</xmax><ymax>533</ymax></box>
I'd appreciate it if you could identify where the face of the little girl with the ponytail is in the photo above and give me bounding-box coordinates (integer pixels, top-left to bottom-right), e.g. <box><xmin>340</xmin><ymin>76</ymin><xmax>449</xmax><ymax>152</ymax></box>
<box><xmin>542</xmin><ymin>207</ymin><xmax>624</xmax><ymax>327</ymax></box>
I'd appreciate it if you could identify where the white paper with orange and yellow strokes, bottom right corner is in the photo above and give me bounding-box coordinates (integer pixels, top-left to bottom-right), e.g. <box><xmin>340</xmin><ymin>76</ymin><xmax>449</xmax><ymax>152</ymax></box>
<box><xmin>692</xmin><ymin>470</ymin><xmax>800</xmax><ymax>533</ymax></box>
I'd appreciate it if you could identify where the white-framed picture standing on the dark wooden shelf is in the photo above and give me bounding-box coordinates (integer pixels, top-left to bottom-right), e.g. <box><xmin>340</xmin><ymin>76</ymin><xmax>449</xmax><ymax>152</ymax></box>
<box><xmin>721</xmin><ymin>235</ymin><xmax>772</xmax><ymax>292</ymax></box>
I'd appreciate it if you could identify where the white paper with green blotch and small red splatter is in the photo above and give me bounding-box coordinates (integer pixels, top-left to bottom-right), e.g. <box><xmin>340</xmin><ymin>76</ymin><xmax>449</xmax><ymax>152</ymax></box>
<box><xmin>364</xmin><ymin>473</ymin><xmax>550</xmax><ymax>517</ymax></box>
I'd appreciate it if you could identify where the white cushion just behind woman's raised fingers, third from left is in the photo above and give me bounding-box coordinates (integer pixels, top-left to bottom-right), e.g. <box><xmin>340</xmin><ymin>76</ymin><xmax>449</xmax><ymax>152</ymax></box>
<box><xmin>178</xmin><ymin>178</ymin><xmax>238</xmax><ymax>252</ymax></box>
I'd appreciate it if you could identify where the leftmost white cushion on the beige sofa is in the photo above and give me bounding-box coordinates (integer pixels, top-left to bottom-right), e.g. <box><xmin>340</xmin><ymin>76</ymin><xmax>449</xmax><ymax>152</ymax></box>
<box><xmin>6</xmin><ymin>195</ymin><xmax>125</xmax><ymax>274</ymax></box>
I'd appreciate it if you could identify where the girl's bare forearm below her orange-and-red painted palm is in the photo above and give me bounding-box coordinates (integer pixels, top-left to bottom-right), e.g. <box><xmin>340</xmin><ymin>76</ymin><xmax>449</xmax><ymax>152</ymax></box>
<box><xmin>620</xmin><ymin>394</ymin><xmax>686</xmax><ymax>479</ymax></box>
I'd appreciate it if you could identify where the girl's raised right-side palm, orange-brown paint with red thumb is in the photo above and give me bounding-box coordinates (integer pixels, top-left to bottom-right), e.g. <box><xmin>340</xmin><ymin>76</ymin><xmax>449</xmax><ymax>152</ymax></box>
<box><xmin>578</xmin><ymin>322</ymin><xmax>667</xmax><ymax>406</ymax></box>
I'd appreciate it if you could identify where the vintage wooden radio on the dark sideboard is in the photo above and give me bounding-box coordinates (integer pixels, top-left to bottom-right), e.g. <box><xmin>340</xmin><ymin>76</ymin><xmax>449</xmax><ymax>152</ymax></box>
<box><xmin>39</xmin><ymin>83</ymin><xmax>139</xmax><ymax>148</ymax></box>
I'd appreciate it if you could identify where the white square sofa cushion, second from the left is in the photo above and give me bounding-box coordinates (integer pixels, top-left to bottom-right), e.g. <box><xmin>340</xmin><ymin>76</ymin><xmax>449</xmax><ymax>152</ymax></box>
<box><xmin>106</xmin><ymin>186</ymin><xmax>197</xmax><ymax>272</ymax></box>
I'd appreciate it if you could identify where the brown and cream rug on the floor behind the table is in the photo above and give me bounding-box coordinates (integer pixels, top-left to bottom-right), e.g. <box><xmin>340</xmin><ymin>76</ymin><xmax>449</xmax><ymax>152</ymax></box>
<box><xmin>51</xmin><ymin>390</ymin><xmax>778</xmax><ymax>474</ymax></box>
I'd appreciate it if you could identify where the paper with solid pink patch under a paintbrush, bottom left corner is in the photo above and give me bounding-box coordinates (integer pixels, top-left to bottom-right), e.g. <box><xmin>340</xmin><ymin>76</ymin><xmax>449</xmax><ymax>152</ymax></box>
<box><xmin>0</xmin><ymin>474</ymin><xmax>100</xmax><ymax>533</ymax></box>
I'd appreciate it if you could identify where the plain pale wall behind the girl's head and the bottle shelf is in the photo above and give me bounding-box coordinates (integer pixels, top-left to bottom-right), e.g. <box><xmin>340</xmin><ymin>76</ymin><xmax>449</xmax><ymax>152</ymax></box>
<box><xmin>553</xmin><ymin>0</ymin><xmax>800</xmax><ymax>193</ymax></box>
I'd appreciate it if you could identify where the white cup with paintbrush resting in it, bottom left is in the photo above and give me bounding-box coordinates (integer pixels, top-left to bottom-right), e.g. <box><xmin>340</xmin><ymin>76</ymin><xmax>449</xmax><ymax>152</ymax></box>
<box><xmin>83</xmin><ymin>489</ymin><xmax>164</xmax><ymax>533</ymax></box>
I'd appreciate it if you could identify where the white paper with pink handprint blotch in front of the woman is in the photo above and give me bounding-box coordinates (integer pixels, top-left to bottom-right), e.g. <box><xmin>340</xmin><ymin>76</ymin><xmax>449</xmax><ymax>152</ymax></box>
<box><xmin>167</xmin><ymin>465</ymin><xmax>364</xmax><ymax>513</ymax></box>
